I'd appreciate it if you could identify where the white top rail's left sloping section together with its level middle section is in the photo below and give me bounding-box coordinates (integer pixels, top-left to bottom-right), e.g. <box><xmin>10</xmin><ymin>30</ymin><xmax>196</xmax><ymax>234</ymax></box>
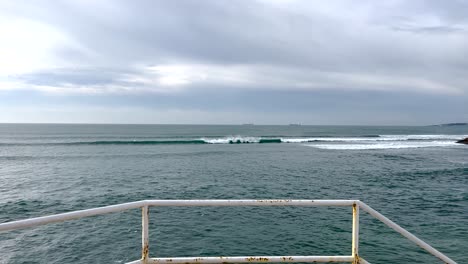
<box><xmin>0</xmin><ymin>200</ymin><xmax>358</xmax><ymax>231</ymax></box>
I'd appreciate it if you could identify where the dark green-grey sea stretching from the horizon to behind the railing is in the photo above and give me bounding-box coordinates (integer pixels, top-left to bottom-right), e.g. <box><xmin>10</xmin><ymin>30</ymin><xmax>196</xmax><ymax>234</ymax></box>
<box><xmin>0</xmin><ymin>124</ymin><xmax>468</xmax><ymax>263</ymax></box>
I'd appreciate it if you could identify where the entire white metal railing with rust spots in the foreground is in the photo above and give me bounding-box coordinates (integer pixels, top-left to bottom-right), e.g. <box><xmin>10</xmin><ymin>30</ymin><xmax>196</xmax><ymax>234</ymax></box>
<box><xmin>0</xmin><ymin>200</ymin><xmax>456</xmax><ymax>264</ymax></box>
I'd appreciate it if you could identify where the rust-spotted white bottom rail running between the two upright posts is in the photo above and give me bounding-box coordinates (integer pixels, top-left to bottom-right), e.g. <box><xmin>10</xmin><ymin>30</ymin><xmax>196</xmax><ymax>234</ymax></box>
<box><xmin>148</xmin><ymin>256</ymin><xmax>354</xmax><ymax>264</ymax></box>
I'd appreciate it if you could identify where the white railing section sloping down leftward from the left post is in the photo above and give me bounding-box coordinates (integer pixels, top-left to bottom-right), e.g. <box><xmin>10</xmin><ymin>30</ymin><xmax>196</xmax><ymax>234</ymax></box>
<box><xmin>0</xmin><ymin>201</ymin><xmax>145</xmax><ymax>231</ymax></box>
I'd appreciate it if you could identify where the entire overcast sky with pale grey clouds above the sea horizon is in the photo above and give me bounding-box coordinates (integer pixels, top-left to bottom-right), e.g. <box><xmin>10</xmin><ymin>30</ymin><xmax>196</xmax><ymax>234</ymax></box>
<box><xmin>0</xmin><ymin>0</ymin><xmax>468</xmax><ymax>125</ymax></box>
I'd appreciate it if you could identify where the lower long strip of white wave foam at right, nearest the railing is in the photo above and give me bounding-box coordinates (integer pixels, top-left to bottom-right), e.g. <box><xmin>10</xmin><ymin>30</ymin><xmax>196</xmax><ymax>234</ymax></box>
<box><xmin>305</xmin><ymin>141</ymin><xmax>459</xmax><ymax>150</ymax></box>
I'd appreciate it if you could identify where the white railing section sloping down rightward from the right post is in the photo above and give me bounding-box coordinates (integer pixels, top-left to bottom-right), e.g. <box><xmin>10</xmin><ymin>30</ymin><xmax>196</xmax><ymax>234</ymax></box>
<box><xmin>359</xmin><ymin>201</ymin><xmax>457</xmax><ymax>264</ymax></box>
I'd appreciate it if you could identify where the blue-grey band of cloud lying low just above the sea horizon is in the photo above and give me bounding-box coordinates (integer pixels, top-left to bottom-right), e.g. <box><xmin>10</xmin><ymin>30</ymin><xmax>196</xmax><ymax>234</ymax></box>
<box><xmin>2</xmin><ymin>87</ymin><xmax>468</xmax><ymax>125</ymax></box>
